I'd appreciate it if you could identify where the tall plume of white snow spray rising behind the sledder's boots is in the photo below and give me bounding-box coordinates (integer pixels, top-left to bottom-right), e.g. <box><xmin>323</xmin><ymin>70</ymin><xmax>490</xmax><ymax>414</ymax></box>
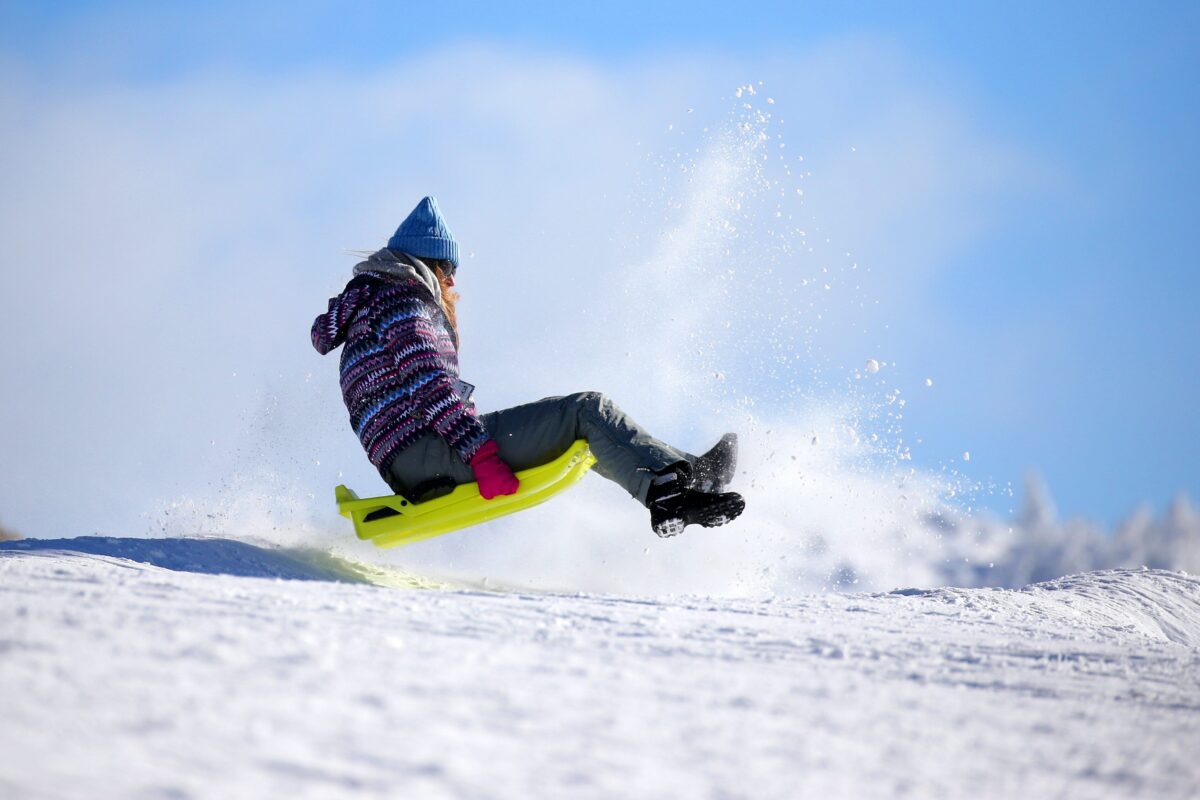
<box><xmin>372</xmin><ymin>85</ymin><xmax>1000</xmax><ymax>595</ymax></box>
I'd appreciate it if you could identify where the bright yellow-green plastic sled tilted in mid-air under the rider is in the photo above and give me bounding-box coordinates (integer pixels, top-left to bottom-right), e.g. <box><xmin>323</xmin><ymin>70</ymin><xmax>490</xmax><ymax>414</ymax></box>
<box><xmin>334</xmin><ymin>439</ymin><xmax>596</xmax><ymax>547</ymax></box>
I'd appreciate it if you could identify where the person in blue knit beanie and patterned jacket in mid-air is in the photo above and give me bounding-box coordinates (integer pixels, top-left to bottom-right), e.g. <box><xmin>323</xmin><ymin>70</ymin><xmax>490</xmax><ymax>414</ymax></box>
<box><xmin>312</xmin><ymin>197</ymin><xmax>745</xmax><ymax>536</ymax></box>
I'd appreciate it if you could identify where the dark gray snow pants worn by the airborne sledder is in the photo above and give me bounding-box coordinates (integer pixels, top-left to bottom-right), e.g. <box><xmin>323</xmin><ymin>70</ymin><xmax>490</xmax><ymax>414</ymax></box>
<box><xmin>384</xmin><ymin>392</ymin><xmax>696</xmax><ymax>505</ymax></box>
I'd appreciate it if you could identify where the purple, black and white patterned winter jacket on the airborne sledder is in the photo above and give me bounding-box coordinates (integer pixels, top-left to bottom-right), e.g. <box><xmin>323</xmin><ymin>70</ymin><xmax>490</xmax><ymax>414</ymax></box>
<box><xmin>312</xmin><ymin>249</ymin><xmax>488</xmax><ymax>480</ymax></box>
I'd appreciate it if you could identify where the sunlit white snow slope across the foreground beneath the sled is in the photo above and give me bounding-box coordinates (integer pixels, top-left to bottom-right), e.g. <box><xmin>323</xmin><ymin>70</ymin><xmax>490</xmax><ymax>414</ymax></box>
<box><xmin>0</xmin><ymin>540</ymin><xmax>1200</xmax><ymax>798</ymax></box>
